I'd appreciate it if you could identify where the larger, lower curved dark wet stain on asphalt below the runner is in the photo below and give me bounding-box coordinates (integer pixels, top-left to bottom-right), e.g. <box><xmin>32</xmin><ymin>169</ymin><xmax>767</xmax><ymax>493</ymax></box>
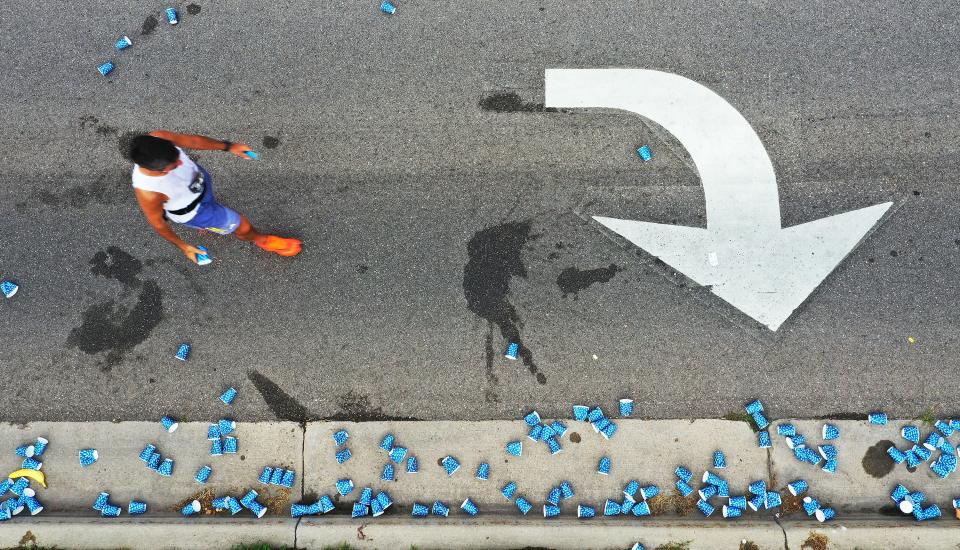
<box><xmin>67</xmin><ymin>281</ymin><xmax>163</xmax><ymax>367</ymax></box>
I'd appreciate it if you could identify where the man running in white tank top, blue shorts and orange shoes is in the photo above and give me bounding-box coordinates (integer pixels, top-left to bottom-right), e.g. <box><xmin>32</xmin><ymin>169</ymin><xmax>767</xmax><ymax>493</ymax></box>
<box><xmin>130</xmin><ymin>130</ymin><xmax>302</xmax><ymax>262</ymax></box>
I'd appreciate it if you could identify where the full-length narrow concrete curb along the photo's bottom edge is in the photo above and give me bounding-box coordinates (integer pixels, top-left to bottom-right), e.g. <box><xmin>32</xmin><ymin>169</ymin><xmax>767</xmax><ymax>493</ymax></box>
<box><xmin>0</xmin><ymin>514</ymin><xmax>960</xmax><ymax>550</ymax></box>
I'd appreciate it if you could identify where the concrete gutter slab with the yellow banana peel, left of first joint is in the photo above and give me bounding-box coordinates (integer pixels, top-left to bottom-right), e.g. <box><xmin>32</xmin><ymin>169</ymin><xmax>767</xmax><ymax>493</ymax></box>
<box><xmin>0</xmin><ymin>421</ymin><xmax>303</xmax><ymax>522</ymax></box>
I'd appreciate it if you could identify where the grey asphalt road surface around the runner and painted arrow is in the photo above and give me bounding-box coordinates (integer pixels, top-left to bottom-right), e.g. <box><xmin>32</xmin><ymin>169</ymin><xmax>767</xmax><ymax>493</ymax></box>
<box><xmin>0</xmin><ymin>0</ymin><xmax>960</xmax><ymax>421</ymax></box>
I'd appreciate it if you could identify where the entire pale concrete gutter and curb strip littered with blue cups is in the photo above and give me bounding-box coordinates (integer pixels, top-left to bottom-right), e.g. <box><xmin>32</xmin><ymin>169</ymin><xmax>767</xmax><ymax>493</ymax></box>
<box><xmin>0</xmin><ymin>419</ymin><xmax>960</xmax><ymax>550</ymax></box>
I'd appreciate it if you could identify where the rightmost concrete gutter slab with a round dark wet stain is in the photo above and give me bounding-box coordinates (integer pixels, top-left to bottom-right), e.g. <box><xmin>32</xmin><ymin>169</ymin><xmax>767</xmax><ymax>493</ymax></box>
<box><xmin>770</xmin><ymin>420</ymin><xmax>960</xmax><ymax>519</ymax></box>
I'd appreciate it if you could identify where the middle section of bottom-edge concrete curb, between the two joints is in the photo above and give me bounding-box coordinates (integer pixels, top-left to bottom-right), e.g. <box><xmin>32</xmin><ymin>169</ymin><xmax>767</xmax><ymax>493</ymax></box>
<box><xmin>297</xmin><ymin>517</ymin><xmax>788</xmax><ymax>550</ymax></box>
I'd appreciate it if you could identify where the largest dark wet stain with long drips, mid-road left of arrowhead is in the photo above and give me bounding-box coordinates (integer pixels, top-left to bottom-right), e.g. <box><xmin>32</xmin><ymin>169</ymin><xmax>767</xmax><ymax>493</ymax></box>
<box><xmin>463</xmin><ymin>221</ymin><xmax>547</xmax><ymax>384</ymax></box>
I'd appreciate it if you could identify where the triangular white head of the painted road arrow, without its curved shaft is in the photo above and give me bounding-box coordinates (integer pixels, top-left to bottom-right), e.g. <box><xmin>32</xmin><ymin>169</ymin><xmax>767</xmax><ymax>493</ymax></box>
<box><xmin>593</xmin><ymin>202</ymin><xmax>893</xmax><ymax>331</ymax></box>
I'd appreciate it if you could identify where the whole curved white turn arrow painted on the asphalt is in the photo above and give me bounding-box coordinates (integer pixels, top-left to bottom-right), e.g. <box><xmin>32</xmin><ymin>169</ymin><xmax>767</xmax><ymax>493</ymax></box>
<box><xmin>544</xmin><ymin>69</ymin><xmax>893</xmax><ymax>331</ymax></box>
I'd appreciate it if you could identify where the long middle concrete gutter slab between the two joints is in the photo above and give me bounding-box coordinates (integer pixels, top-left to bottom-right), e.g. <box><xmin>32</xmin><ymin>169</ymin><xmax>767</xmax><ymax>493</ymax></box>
<box><xmin>304</xmin><ymin>419</ymin><xmax>767</xmax><ymax>516</ymax></box>
